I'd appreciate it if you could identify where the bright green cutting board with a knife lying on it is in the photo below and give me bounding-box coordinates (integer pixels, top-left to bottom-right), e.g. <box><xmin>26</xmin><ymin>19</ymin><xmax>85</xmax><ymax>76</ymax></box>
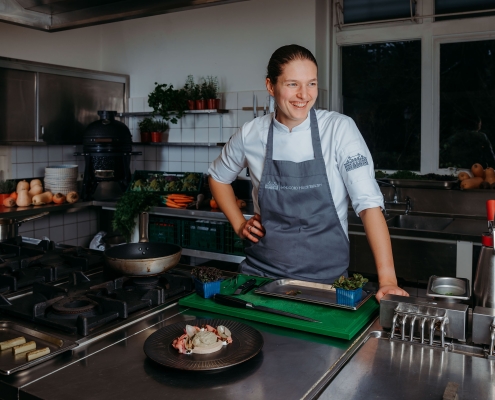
<box><xmin>179</xmin><ymin>275</ymin><xmax>379</xmax><ymax>340</ymax></box>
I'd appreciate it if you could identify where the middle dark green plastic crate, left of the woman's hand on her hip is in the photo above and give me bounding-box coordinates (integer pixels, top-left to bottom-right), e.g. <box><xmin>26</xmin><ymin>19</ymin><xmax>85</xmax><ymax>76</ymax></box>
<box><xmin>182</xmin><ymin>220</ymin><xmax>226</xmax><ymax>253</ymax></box>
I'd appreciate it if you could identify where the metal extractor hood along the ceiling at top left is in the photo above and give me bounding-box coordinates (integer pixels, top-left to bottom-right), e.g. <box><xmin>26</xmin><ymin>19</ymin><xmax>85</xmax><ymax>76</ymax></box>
<box><xmin>0</xmin><ymin>0</ymin><xmax>246</xmax><ymax>32</ymax></box>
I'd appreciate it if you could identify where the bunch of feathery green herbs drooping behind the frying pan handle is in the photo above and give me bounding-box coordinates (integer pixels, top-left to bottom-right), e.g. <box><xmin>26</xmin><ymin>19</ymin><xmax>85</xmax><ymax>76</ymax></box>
<box><xmin>112</xmin><ymin>192</ymin><xmax>160</xmax><ymax>243</ymax></box>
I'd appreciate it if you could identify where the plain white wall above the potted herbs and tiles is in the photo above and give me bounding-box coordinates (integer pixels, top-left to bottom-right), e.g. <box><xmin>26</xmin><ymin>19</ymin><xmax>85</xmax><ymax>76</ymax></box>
<box><xmin>101</xmin><ymin>0</ymin><xmax>316</xmax><ymax>97</ymax></box>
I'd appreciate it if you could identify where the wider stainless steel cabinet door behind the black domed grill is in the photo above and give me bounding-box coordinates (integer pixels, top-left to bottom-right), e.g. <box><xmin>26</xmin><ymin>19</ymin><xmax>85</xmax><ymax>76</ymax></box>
<box><xmin>39</xmin><ymin>73</ymin><xmax>125</xmax><ymax>144</ymax></box>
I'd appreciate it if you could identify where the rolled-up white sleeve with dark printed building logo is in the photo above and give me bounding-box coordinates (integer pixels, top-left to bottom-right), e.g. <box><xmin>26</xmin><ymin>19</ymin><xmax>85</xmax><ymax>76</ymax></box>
<box><xmin>336</xmin><ymin>118</ymin><xmax>384</xmax><ymax>215</ymax></box>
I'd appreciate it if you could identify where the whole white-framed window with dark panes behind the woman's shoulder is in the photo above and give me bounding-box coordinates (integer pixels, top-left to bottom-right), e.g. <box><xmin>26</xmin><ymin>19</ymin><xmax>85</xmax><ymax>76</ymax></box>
<box><xmin>329</xmin><ymin>0</ymin><xmax>495</xmax><ymax>174</ymax></box>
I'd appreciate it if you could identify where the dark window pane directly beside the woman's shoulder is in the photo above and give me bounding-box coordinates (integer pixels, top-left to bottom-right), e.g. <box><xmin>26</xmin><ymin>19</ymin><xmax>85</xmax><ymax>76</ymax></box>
<box><xmin>342</xmin><ymin>40</ymin><xmax>421</xmax><ymax>171</ymax></box>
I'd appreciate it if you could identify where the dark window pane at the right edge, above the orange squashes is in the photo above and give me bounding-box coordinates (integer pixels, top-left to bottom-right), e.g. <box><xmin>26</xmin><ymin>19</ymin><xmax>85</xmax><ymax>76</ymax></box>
<box><xmin>440</xmin><ymin>40</ymin><xmax>495</xmax><ymax>168</ymax></box>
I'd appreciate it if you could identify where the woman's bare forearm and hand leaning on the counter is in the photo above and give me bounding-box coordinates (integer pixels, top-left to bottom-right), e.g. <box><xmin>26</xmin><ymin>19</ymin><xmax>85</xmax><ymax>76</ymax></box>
<box><xmin>359</xmin><ymin>207</ymin><xmax>409</xmax><ymax>301</ymax></box>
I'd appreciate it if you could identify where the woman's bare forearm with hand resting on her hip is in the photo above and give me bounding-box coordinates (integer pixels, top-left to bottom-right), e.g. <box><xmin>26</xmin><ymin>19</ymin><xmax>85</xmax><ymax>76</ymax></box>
<box><xmin>208</xmin><ymin>176</ymin><xmax>265</xmax><ymax>243</ymax></box>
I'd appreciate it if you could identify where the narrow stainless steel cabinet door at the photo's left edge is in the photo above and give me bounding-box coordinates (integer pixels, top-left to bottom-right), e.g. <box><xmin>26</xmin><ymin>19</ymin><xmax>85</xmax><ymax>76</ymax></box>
<box><xmin>0</xmin><ymin>68</ymin><xmax>36</xmax><ymax>142</ymax></box>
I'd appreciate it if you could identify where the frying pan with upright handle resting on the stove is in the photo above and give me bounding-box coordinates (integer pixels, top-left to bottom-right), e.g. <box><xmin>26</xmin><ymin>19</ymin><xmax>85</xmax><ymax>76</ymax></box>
<box><xmin>104</xmin><ymin>213</ymin><xmax>182</xmax><ymax>277</ymax></box>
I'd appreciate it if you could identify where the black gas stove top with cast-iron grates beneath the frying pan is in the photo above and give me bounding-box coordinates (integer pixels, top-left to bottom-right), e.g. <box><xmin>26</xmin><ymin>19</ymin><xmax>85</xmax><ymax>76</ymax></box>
<box><xmin>0</xmin><ymin>237</ymin><xmax>194</xmax><ymax>374</ymax></box>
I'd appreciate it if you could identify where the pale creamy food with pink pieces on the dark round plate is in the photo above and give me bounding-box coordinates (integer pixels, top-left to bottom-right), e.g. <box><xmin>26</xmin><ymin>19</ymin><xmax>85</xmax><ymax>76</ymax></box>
<box><xmin>172</xmin><ymin>324</ymin><xmax>232</xmax><ymax>354</ymax></box>
